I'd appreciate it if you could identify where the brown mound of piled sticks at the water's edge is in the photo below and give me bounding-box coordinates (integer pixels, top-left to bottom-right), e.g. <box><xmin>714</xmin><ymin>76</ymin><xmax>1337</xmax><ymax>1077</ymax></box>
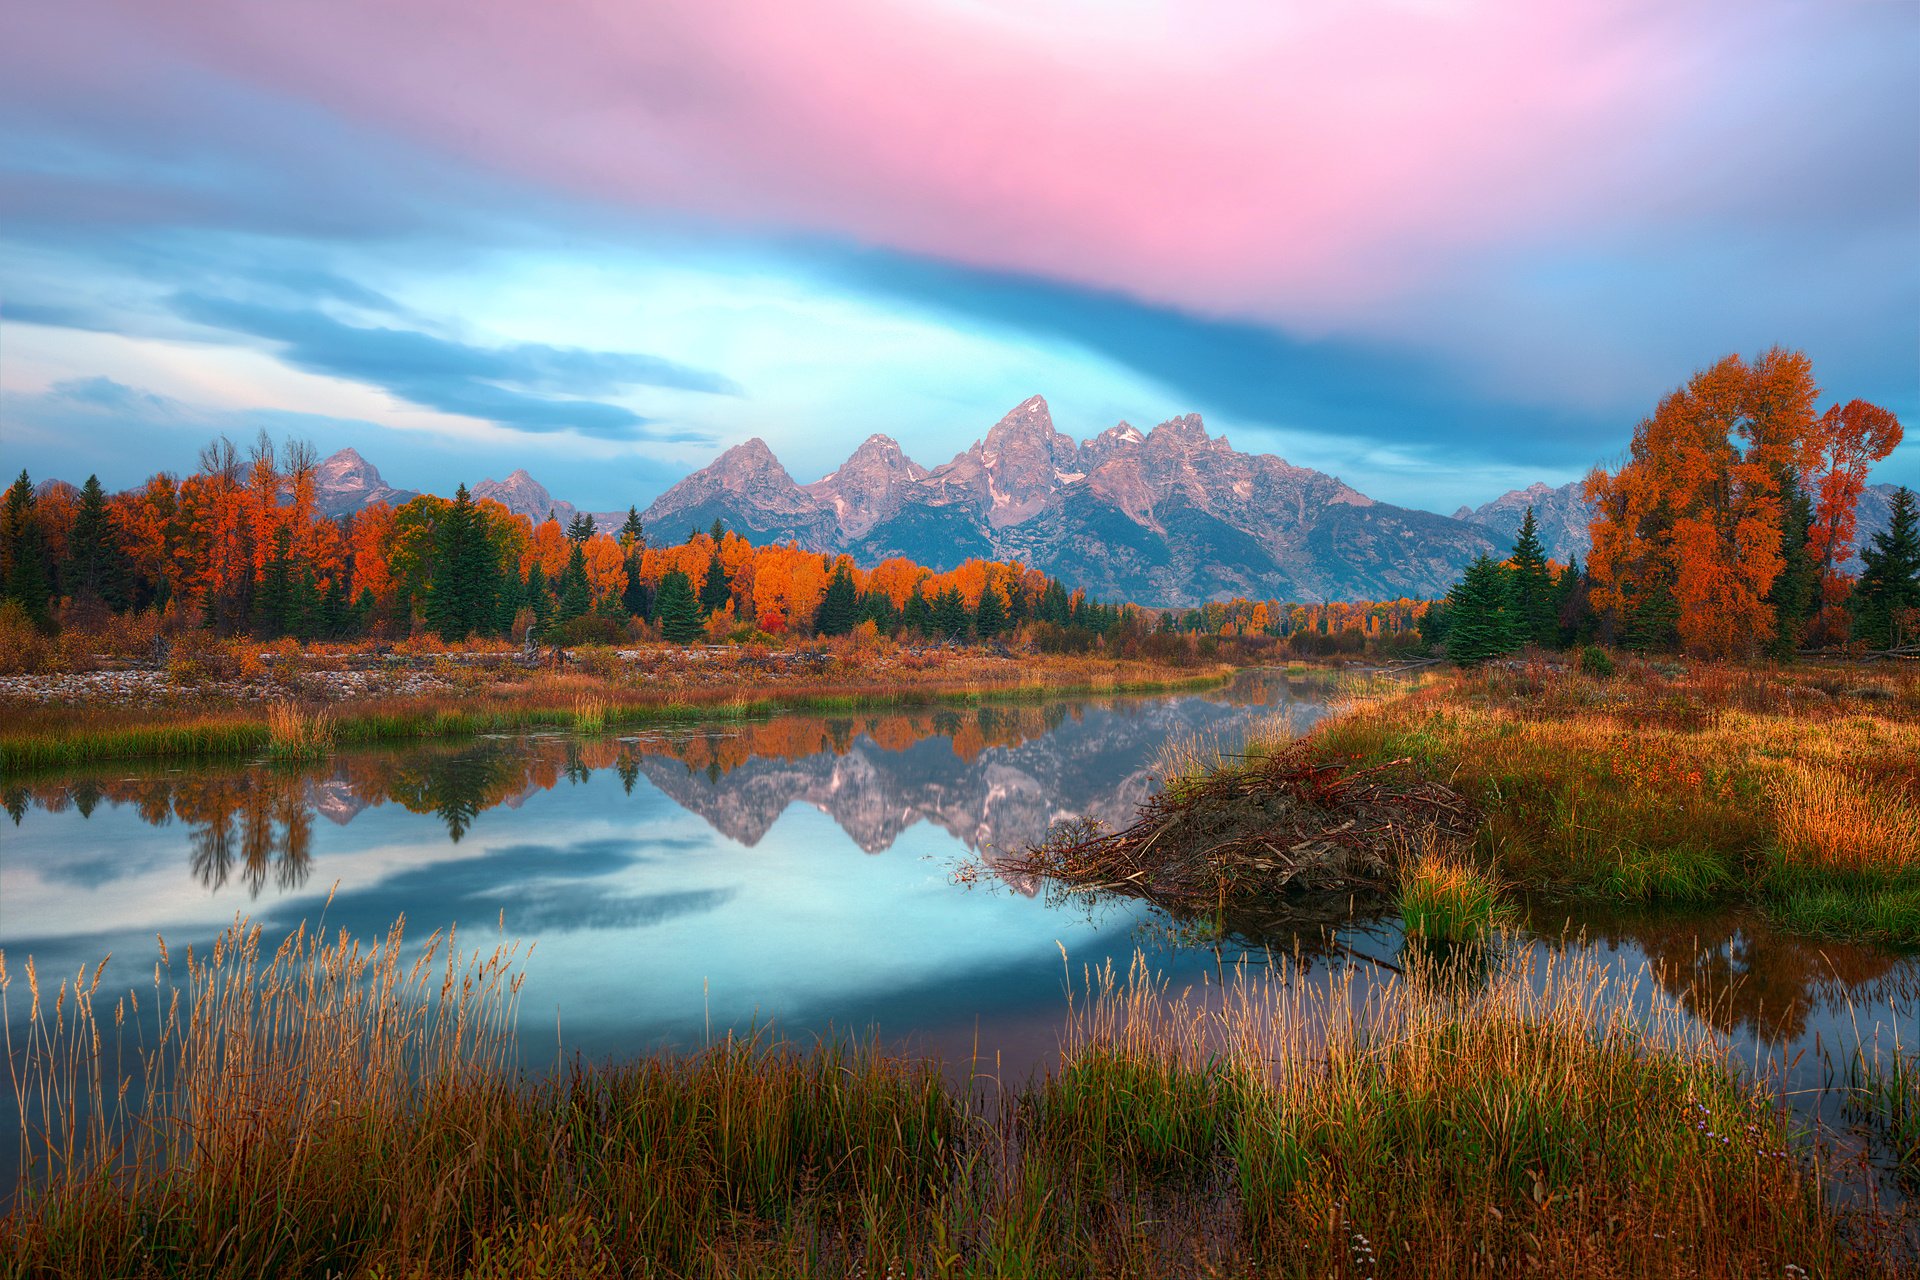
<box><xmin>1000</xmin><ymin>750</ymin><xmax>1478</xmax><ymax>915</ymax></box>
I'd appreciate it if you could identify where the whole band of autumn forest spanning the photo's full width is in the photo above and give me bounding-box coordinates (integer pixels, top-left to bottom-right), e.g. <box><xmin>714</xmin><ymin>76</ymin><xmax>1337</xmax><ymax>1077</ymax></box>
<box><xmin>0</xmin><ymin>349</ymin><xmax>1920</xmax><ymax>662</ymax></box>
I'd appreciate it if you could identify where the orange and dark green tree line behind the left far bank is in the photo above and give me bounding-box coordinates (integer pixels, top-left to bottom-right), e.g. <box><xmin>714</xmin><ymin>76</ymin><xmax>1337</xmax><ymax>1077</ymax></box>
<box><xmin>0</xmin><ymin>434</ymin><xmax>1146</xmax><ymax>649</ymax></box>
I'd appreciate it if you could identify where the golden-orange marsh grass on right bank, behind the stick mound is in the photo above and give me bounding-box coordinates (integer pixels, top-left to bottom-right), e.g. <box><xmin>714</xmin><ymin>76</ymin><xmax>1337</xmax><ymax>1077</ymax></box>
<box><xmin>1304</xmin><ymin>660</ymin><xmax>1920</xmax><ymax>944</ymax></box>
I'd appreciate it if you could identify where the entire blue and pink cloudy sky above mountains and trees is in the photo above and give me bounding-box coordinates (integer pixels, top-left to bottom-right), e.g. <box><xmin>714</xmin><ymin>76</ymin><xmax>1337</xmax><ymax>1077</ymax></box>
<box><xmin>0</xmin><ymin>0</ymin><xmax>1920</xmax><ymax>510</ymax></box>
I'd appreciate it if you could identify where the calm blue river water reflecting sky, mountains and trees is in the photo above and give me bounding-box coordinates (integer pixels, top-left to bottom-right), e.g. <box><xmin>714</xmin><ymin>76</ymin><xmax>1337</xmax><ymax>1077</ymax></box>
<box><xmin>0</xmin><ymin>676</ymin><xmax>1920</xmax><ymax>1212</ymax></box>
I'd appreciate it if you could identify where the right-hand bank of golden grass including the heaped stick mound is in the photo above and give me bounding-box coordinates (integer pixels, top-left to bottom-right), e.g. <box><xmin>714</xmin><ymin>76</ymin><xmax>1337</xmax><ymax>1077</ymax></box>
<box><xmin>1023</xmin><ymin>662</ymin><xmax>1920</xmax><ymax>946</ymax></box>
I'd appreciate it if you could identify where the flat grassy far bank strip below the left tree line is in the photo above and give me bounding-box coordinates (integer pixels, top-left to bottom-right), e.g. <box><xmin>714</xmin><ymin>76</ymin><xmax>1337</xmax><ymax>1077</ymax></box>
<box><xmin>0</xmin><ymin>643</ymin><xmax>1235</xmax><ymax>775</ymax></box>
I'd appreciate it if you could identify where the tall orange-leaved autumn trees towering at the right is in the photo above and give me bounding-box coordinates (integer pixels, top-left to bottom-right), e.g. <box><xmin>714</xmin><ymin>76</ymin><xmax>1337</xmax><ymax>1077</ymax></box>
<box><xmin>1586</xmin><ymin>347</ymin><xmax>1901</xmax><ymax>658</ymax></box>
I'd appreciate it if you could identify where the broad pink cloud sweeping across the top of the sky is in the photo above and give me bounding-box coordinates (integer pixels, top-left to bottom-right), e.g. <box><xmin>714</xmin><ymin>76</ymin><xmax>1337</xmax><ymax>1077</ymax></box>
<box><xmin>0</xmin><ymin>0</ymin><xmax>1827</xmax><ymax>326</ymax></box>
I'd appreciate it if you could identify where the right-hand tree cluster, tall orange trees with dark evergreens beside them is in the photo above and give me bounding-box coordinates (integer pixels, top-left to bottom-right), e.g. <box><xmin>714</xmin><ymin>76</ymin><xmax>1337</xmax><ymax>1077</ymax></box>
<box><xmin>1423</xmin><ymin>347</ymin><xmax>1920</xmax><ymax>662</ymax></box>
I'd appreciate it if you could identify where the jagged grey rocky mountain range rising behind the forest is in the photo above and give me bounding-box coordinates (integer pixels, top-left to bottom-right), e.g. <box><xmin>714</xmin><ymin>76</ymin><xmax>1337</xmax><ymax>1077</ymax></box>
<box><xmin>299</xmin><ymin>395</ymin><xmax>1893</xmax><ymax>606</ymax></box>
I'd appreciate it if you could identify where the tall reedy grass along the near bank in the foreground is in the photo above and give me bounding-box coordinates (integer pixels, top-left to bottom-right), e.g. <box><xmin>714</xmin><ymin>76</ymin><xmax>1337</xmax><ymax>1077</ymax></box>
<box><xmin>11</xmin><ymin>927</ymin><xmax>1910</xmax><ymax>1278</ymax></box>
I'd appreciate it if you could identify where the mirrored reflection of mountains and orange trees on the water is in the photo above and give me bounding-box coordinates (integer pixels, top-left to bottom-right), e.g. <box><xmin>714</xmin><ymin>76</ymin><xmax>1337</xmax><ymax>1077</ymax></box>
<box><xmin>4</xmin><ymin>687</ymin><xmax>1319</xmax><ymax>898</ymax></box>
